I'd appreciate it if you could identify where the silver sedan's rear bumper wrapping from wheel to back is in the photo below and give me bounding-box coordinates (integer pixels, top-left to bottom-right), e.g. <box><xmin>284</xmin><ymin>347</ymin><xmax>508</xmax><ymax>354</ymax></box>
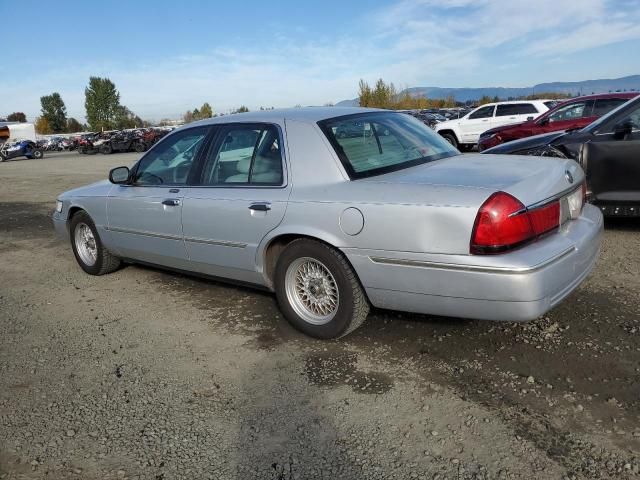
<box><xmin>344</xmin><ymin>205</ymin><xmax>603</xmax><ymax>321</ymax></box>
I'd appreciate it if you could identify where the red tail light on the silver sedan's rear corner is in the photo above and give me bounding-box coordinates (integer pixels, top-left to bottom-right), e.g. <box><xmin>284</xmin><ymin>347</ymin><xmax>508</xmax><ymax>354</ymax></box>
<box><xmin>470</xmin><ymin>192</ymin><xmax>560</xmax><ymax>255</ymax></box>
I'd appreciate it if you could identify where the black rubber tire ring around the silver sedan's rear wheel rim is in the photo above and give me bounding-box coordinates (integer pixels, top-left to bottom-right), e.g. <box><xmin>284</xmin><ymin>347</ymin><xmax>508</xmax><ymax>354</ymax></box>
<box><xmin>274</xmin><ymin>240</ymin><xmax>354</xmax><ymax>339</ymax></box>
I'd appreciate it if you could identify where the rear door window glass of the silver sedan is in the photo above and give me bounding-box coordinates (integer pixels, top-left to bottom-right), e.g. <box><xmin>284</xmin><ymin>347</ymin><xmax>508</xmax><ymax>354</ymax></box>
<box><xmin>201</xmin><ymin>125</ymin><xmax>283</xmax><ymax>185</ymax></box>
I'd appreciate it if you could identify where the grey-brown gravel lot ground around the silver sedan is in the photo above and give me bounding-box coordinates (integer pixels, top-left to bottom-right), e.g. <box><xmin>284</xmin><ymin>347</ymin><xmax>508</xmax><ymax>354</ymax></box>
<box><xmin>0</xmin><ymin>153</ymin><xmax>640</xmax><ymax>480</ymax></box>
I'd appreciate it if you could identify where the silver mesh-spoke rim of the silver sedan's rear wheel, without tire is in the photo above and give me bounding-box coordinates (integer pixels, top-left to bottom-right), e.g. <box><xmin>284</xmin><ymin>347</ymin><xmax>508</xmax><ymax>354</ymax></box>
<box><xmin>285</xmin><ymin>257</ymin><xmax>339</xmax><ymax>325</ymax></box>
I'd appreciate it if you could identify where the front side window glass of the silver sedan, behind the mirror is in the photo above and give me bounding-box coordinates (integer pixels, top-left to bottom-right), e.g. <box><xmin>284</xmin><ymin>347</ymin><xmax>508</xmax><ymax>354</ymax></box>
<box><xmin>134</xmin><ymin>127</ymin><xmax>209</xmax><ymax>185</ymax></box>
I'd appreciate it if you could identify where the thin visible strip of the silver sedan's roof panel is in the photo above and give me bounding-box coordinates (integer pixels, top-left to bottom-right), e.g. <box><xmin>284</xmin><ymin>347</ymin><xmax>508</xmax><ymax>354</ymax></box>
<box><xmin>181</xmin><ymin>107</ymin><xmax>384</xmax><ymax>128</ymax></box>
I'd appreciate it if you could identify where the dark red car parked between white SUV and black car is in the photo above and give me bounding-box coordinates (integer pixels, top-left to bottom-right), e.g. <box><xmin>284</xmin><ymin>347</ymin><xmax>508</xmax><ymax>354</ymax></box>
<box><xmin>478</xmin><ymin>92</ymin><xmax>640</xmax><ymax>151</ymax></box>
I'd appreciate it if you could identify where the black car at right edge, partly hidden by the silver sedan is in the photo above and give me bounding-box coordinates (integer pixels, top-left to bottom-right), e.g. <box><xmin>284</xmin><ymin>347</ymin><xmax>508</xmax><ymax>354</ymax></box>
<box><xmin>482</xmin><ymin>96</ymin><xmax>640</xmax><ymax>217</ymax></box>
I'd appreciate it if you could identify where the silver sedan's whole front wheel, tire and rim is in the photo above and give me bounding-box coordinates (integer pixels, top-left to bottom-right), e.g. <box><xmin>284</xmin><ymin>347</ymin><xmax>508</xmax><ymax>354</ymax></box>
<box><xmin>69</xmin><ymin>212</ymin><xmax>120</xmax><ymax>275</ymax></box>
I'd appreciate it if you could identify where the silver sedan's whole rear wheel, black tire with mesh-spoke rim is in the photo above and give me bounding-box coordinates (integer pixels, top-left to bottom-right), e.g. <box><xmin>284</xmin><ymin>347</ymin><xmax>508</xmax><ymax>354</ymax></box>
<box><xmin>274</xmin><ymin>239</ymin><xmax>369</xmax><ymax>339</ymax></box>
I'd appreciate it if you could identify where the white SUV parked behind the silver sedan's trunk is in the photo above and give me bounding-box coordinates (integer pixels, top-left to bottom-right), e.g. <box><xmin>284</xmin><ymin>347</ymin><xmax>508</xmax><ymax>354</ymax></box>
<box><xmin>435</xmin><ymin>100</ymin><xmax>553</xmax><ymax>148</ymax></box>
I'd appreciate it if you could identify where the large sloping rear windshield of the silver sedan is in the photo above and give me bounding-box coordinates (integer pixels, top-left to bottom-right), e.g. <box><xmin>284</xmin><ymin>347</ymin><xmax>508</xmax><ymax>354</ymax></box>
<box><xmin>318</xmin><ymin>112</ymin><xmax>460</xmax><ymax>179</ymax></box>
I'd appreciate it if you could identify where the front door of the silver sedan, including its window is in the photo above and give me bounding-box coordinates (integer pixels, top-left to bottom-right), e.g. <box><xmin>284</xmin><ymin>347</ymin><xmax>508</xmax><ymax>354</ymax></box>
<box><xmin>107</xmin><ymin>127</ymin><xmax>209</xmax><ymax>268</ymax></box>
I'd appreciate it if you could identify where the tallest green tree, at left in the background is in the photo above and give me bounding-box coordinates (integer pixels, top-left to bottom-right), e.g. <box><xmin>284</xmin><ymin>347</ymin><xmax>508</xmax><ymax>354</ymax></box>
<box><xmin>84</xmin><ymin>77</ymin><xmax>122</xmax><ymax>130</ymax></box>
